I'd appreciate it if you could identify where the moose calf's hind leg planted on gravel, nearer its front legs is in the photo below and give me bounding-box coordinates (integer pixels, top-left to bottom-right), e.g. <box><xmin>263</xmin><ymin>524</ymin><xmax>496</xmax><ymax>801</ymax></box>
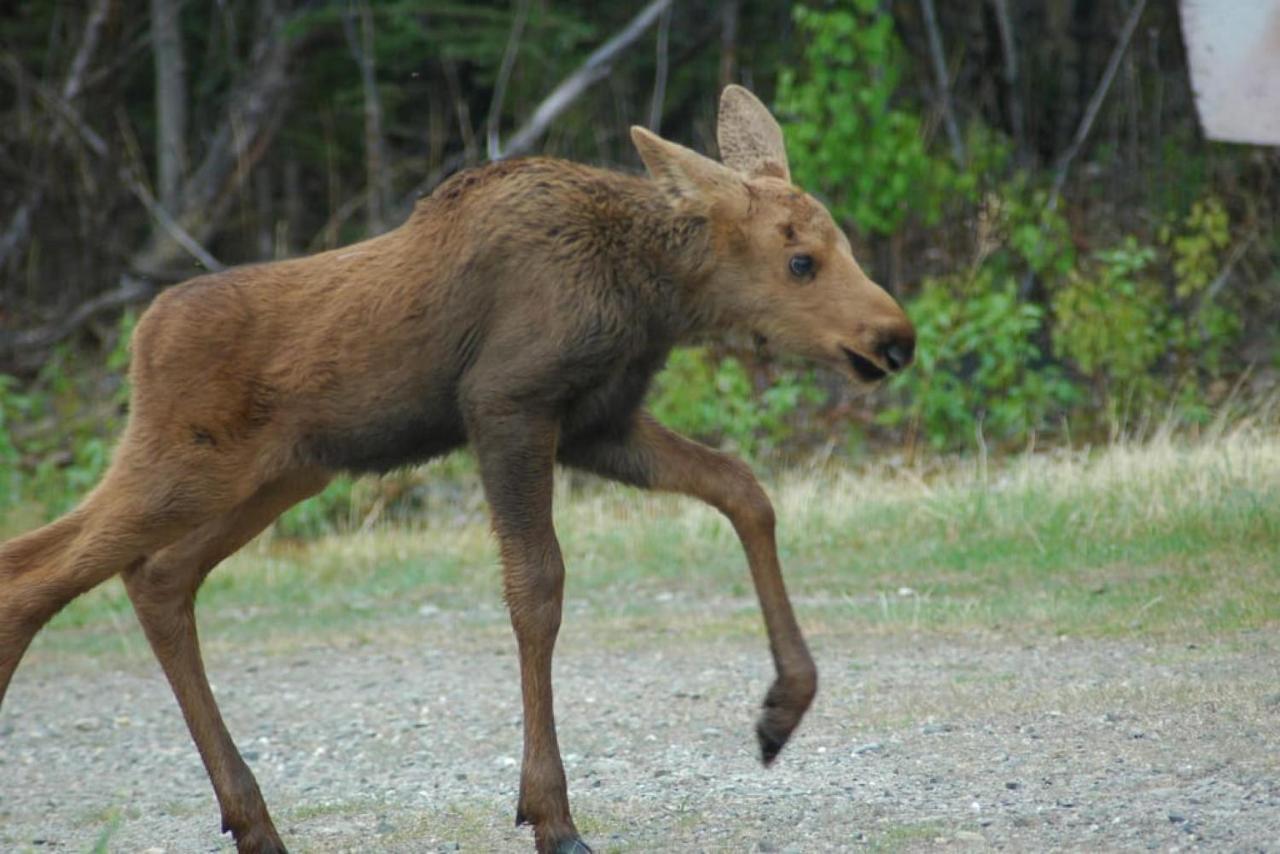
<box><xmin>124</xmin><ymin>472</ymin><xmax>328</xmax><ymax>854</ymax></box>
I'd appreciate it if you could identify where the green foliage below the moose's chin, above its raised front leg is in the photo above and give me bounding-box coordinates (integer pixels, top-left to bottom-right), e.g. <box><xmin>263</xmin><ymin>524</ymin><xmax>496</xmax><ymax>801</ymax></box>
<box><xmin>649</xmin><ymin>348</ymin><xmax>823</xmax><ymax>456</ymax></box>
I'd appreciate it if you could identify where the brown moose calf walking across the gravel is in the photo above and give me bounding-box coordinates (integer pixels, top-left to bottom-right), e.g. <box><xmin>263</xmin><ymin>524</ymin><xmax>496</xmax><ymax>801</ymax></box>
<box><xmin>0</xmin><ymin>87</ymin><xmax>914</xmax><ymax>851</ymax></box>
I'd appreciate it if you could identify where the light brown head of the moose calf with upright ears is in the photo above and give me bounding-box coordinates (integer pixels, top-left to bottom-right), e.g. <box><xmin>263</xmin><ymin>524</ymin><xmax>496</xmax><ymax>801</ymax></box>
<box><xmin>631</xmin><ymin>86</ymin><xmax>915</xmax><ymax>383</ymax></box>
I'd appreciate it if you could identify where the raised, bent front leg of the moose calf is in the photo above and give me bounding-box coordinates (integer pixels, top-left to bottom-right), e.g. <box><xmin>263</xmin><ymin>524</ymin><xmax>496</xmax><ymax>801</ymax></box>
<box><xmin>559</xmin><ymin>412</ymin><xmax>818</xmax><ymax>764</ymax></box>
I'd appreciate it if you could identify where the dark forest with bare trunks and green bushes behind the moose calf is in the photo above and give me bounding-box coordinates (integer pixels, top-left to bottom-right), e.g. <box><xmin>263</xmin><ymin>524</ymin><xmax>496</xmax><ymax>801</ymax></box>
<box><xmin>0</xmin><ymin>0</ymin><xmax>1280</xmax><ymax>535</ymax></box>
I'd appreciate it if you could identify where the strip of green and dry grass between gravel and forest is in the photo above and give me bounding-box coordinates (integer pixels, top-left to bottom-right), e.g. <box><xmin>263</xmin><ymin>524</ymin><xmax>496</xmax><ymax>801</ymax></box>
<box><xmin>20</xmin><ymin>431</ymin><xmax>1280</xmax><ymax>652</ymax></box>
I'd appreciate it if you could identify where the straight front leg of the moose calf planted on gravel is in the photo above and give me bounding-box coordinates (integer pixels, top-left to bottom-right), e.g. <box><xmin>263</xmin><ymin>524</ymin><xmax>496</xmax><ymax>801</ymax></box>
<box><xmin>471</xmin><ymin>412</ymin><xmax>590</xmax><ymax>854</ymax></box>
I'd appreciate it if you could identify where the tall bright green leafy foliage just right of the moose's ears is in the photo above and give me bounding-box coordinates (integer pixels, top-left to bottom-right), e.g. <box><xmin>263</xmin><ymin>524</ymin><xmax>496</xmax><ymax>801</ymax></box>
<box><xmin>777</xmin><ymin>0</ymin><xmax>956</xmax><ymax>234</ymax></box>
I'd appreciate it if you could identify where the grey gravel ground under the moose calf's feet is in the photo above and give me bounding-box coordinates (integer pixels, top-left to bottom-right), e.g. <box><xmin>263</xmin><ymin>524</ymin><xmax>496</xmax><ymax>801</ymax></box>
<box><xmin>0</xmin><ymin>615</ymin><xmax>1280</xmax><ymax>853</ymax></box>
